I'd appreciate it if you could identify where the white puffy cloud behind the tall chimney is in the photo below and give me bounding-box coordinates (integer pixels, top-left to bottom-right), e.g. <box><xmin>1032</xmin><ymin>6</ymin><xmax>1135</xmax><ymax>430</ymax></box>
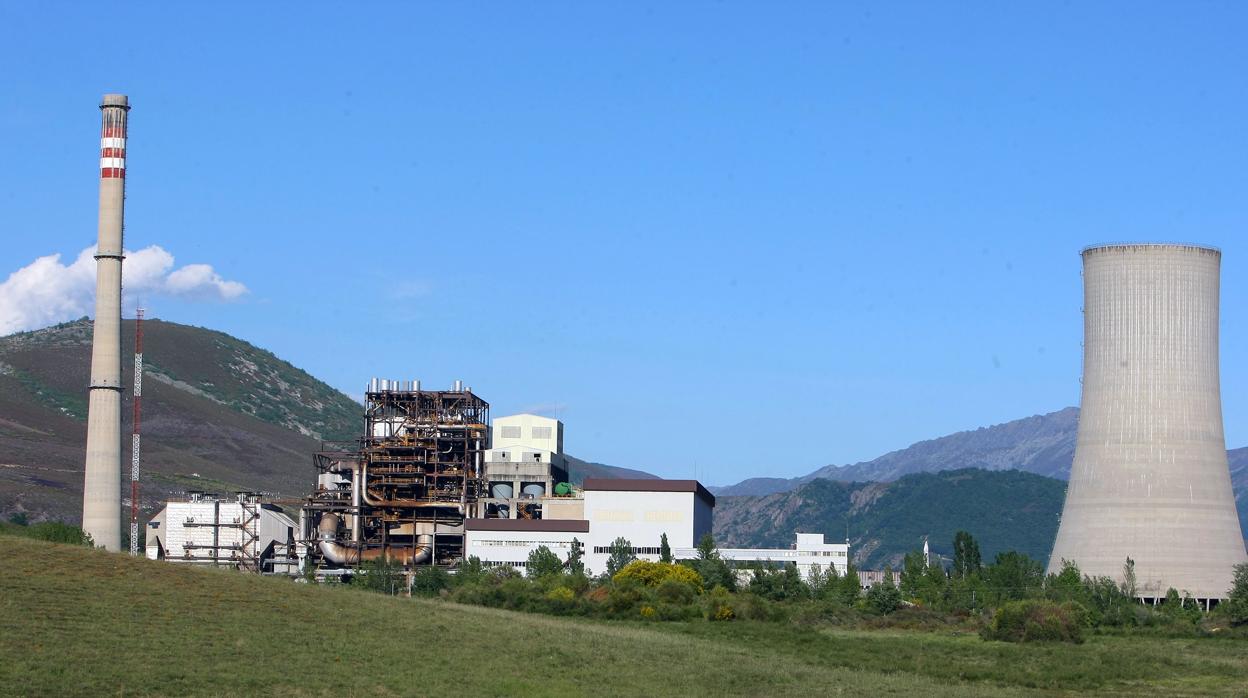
<box><xmin>0</xmin><ymin>245</ymin><xmax>247</xmax><ymax>335</ymax></box>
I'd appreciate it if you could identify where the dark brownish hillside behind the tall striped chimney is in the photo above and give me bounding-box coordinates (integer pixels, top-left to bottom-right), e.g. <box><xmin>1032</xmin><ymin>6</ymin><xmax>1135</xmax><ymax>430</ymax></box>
<box><xmin>0</xmin><ymin>320</ymin><xmax>362</xmax><ymax>521</ymax></box>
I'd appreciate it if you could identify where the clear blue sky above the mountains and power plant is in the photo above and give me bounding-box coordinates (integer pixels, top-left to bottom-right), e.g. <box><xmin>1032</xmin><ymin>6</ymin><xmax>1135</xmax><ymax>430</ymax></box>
<box><xmin>0</xmin><ymin>2</ymin><xmax>1248</xmax><ymax>484</ymax></box>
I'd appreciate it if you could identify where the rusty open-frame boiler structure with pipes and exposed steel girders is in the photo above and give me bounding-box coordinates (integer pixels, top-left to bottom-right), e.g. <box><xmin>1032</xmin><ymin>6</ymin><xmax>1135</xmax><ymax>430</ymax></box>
<box><xmin>300</xmin><ymin>378</ymin><xmax>489</xmax><ymax>573</ymax></box>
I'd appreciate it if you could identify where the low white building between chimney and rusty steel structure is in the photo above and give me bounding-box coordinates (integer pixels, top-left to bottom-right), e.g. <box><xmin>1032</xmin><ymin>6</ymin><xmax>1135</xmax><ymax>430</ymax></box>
<box><xmin>147</xmin><ymin>492</ymin><xmax>298</xmax><ymax>572</ymax></box>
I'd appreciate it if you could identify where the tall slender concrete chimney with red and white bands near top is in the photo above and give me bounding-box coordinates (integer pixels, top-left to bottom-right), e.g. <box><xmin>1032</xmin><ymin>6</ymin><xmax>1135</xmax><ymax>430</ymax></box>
<box><xmin>82</xmin><ymin>95</ymin><xmax>130</xmax><ymax>551</ymax></box>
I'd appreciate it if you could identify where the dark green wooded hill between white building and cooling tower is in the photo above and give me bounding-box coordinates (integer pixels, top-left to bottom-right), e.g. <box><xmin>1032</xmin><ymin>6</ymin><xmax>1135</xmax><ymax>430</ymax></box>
<box><xmin>715</xmin><ymin>468</ymin><xmax>1066</xmax><ymax>568</ymax></box>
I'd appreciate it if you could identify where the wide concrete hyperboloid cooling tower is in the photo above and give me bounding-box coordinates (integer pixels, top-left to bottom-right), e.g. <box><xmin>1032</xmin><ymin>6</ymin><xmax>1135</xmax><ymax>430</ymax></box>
<box><xmin>1048</xmin><ymin>245</ymin><xmax>1246</xmax><ymax>599</ymax></box>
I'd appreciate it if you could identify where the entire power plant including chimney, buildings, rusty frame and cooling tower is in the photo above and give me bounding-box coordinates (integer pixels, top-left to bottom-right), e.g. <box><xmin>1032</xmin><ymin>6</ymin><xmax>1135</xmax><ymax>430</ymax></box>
<box><xmin>63</xmin><ymin>94</ymin><xmax>1248</xmax><ymax>607</ymax></box>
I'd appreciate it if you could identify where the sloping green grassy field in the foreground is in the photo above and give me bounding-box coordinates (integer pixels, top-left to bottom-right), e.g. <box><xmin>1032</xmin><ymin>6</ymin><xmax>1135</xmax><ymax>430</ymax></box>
<box><xmin>0</xmin><ymin>536</ymin><xmax>1248</xmax><ymax>696</ymax></box>
